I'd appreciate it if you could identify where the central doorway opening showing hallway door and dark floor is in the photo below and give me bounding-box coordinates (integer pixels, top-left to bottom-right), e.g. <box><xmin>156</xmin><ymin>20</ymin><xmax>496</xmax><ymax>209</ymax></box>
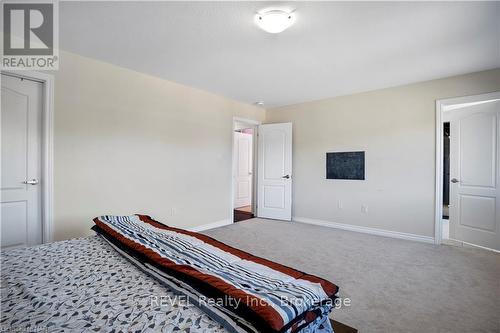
<box><xmin>233</xmin><ymin>119</ymin><xmax>258</xmax><ymax>222</ymax></box>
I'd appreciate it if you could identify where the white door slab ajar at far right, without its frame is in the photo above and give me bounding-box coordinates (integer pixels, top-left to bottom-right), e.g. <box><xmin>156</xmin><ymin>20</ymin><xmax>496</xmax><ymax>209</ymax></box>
<box><xmin>450</xmin><ymin>101</ymin><xmax>500</xmax><ymax>250</ymax></box>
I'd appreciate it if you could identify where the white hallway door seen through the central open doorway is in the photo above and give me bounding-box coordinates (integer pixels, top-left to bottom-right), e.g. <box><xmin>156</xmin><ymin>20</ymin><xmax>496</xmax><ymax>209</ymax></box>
<box><xmin>234</xmin><ymin>132</ymin><xmax>253</xmax><ymax>208</ymax></box>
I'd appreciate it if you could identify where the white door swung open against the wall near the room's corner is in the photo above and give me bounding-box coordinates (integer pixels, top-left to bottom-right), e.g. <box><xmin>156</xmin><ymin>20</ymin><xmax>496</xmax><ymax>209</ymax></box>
<box><xmin>257</xmin><ymin>123</ymin><xmax>292</xmax><ymax>221</ymax></box>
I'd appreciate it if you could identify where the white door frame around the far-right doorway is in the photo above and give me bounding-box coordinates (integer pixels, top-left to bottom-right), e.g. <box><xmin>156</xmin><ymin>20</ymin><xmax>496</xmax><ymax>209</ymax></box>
<box><xmin>434</xmin><ymin>91</ymin><xmax>500</xmax><ymax>246</ymax></box>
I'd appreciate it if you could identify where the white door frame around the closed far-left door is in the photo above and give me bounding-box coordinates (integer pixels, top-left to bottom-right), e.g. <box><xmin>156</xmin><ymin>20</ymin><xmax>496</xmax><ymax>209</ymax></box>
<box><xmin>1</xmin><ymin>70</ymin><xmax>54</xmax><ymax>243</ymax></box>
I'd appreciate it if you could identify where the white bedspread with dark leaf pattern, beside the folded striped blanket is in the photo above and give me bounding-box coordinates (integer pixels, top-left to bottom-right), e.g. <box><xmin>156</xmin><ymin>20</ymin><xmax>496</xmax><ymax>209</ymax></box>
<box><xmin>0</xmin><ymin>236</ymin><xmax>336</xmax><ymax>333</ymax></box>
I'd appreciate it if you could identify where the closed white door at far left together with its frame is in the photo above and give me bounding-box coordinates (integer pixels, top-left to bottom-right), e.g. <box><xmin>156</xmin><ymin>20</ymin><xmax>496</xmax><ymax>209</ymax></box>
<box><xmin>0</xmin><ymin>72</ymin><xmax>52</xmax><ymax>250</ymax></box>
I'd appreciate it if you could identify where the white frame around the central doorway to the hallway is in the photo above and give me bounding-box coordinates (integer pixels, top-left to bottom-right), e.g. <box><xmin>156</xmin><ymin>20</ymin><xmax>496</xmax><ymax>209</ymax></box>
<box><xmin>230</xmin><ymin>117</ymin><xmax>262</xmax><ymax>223</ymax></box>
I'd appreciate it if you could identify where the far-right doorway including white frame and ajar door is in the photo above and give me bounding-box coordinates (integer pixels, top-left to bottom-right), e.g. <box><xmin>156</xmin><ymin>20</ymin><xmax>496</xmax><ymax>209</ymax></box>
<box><xmin>436</xmin><ymin>93</ymin><xmax>500</xmax><ymax>251</ymax></box>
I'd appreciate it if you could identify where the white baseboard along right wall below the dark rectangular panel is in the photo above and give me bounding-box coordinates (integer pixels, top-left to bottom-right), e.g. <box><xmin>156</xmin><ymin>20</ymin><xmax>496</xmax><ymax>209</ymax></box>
<box><xmin>292</xmin><ymin>216</ymin><xmax>434</xmax><ymax>244</ymax></box>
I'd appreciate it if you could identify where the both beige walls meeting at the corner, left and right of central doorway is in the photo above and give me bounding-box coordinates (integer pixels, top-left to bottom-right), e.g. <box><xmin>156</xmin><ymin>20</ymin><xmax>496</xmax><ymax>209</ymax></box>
<box><xmin>54</xmin><ymin>52</ymin><xmax>500</xmax><ymax>240</ymax></box>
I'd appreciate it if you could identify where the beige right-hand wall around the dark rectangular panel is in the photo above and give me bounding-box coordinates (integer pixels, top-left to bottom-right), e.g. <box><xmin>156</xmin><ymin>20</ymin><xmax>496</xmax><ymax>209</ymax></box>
<box><xmin>266</xmin><ymin>69</ymin><xmax>500</xmax><ymax>237</ymax></box>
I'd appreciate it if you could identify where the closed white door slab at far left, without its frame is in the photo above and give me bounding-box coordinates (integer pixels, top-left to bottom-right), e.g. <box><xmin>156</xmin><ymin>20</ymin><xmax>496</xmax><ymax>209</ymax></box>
<box><xmin>0</xmin><ymin>75</ymin><xmax>42</xmax><ymax>249</ymax></box>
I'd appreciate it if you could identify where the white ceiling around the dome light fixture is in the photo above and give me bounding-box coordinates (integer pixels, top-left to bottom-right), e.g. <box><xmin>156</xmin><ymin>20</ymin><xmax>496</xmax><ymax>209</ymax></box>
<box><xmin>60</xmin><ymin>2</ymin><xmax>500</xmax><ymax>107</ymax></box>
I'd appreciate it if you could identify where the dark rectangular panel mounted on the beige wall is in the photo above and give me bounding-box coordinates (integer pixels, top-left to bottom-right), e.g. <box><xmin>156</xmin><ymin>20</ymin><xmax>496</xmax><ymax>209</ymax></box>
<box><xmin>326</xmin><ymin>151</ymin><xmax>365</xmax><ymax>180</ymax></box>
